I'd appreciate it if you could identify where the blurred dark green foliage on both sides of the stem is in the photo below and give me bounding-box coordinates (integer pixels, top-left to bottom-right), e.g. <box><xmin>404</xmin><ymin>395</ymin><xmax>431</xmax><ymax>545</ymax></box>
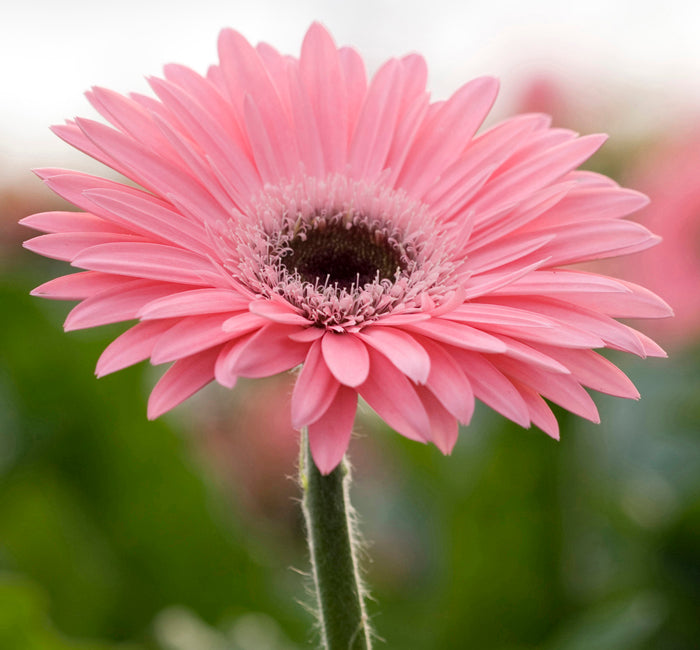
<box><xmin>0</xmin><ymin>208</ymin><xmax>700</xmax><ymax>650</ymax></box>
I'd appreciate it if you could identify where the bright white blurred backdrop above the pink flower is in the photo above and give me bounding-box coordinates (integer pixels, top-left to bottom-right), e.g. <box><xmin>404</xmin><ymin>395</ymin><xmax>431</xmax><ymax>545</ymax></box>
<box><xmin>0</xmin><ymin>0</ymin><xmax>700</xmax><ymax>176</ymax></box>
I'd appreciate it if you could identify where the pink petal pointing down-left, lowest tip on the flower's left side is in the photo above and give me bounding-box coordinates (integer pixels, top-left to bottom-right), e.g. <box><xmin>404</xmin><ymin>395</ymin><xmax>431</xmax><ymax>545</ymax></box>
<box><xmin>148</xmin><ymin>346</ymin><xmax>221</xmax><ymax>420</ymax></box>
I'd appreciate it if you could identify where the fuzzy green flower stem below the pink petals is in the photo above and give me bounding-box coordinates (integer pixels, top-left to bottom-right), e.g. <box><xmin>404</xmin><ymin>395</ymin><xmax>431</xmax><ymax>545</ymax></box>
<box><xmin>299</xmin><ymin>429</ymin><xmax>372</xmax><ymax>650</ymax></box>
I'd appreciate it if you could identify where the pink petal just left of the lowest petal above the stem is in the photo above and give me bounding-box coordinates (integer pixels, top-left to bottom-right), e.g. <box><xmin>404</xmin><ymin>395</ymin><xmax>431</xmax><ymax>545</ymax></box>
<box><xmin>292</xmin><ymin>340</ymin><xmax>340</xmax><ymax>429</ymax></box>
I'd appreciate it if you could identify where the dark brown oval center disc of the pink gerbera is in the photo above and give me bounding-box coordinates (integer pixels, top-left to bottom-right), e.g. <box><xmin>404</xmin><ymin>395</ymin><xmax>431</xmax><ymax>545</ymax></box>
<box><xmin>284</xmin><ymin>221</ymin><xmax>405</xmax><ymax>291</ymax></box>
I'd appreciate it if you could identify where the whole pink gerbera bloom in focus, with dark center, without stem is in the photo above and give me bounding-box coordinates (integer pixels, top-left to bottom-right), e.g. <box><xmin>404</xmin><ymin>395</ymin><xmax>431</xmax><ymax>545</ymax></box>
<box><xmin>23</xmin><ymin>24</ymin><xmax>669</xmax><ymax>473</ymax></box>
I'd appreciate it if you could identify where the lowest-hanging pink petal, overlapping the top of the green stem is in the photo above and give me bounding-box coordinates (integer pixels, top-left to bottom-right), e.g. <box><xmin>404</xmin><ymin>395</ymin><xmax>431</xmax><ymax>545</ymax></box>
<box><xmin>309</xmin><ymin>386</ymin><xmax>357</xmax><ymax>475</ymax></box>
